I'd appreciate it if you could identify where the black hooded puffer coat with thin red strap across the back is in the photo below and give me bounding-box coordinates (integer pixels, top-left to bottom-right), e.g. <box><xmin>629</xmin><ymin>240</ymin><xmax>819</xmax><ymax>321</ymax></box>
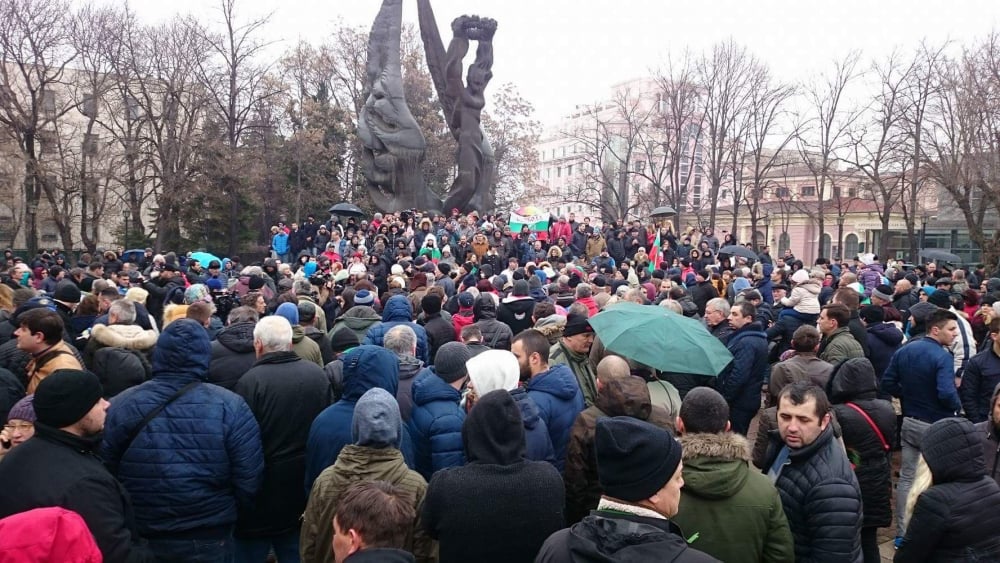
<box><xmin>826</xmin><ymin>358</ymin><xmax>896</xmax><ymax>528</ymax></box>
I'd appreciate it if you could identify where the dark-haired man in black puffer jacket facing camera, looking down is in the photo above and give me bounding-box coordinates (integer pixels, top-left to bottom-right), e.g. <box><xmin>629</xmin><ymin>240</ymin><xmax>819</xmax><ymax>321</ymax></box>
<box><xmin>764</xmin><ymin>381</ymin><xmax>862</xmax><ymax>562</ymax></box>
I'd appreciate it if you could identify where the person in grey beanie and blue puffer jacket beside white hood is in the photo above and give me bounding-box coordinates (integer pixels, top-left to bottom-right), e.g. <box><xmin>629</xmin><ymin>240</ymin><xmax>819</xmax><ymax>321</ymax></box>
<box><xmin>409</xmin><ymin>342</ymin><xmax>472</xmax><ymax>481</ymax></box>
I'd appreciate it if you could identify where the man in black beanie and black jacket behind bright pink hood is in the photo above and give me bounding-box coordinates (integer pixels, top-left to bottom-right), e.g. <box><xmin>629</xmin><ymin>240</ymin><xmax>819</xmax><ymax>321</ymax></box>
<box><xmin>0</xmin><ymin>370</ymin><xmax>154</xmax><ymax>563</ymax></box>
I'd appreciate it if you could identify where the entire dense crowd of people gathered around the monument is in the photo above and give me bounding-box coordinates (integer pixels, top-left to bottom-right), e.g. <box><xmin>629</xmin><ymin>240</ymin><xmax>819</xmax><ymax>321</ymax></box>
<box><xmin>0</xmin><ymin>211</ymin><xmax>1000</xmax><ymax>563</ymax></box>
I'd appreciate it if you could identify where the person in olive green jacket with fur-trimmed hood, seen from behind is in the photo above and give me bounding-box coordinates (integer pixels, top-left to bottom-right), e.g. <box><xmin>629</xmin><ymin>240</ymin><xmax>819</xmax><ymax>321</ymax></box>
<box><xmin>674</xmin><ymin>387</ymin><xmax>795</xmax><ymax>563</ymax></box>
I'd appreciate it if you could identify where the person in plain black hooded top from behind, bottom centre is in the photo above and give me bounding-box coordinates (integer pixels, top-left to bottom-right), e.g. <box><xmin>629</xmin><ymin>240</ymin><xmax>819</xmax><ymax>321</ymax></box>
<box><xmin>422</xmin><ymin>389</ymin><xmax>564</xmax><ymax>563</ymax></box>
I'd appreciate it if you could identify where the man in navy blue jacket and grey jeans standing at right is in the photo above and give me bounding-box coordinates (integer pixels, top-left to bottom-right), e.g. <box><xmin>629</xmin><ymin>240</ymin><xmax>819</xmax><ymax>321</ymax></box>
<box><xmin>882</xmin><ymin>309</ymin><xmax>962</xmax><ymax>547</ymax></box>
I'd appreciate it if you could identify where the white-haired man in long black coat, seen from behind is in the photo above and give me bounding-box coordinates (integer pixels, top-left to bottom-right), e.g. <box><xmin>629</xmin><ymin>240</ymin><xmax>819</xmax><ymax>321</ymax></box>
<box><xmin>233</xmin><ymin>316</ymin><xmax>331</xmax><ymax>561</ymax></box>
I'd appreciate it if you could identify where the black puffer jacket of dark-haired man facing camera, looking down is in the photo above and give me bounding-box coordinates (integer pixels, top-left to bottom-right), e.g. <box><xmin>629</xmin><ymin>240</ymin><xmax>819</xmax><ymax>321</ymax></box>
<box><xmin>763</xmin><ymin>424</ymin><xmax>863</xmax><ymax>563</ymax></box>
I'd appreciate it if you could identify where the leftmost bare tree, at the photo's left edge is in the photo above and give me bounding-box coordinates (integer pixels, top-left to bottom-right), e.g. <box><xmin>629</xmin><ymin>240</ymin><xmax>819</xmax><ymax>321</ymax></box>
<box><xmin>0</xmin><ymin>0</ymin><xmax>76</xmax><ymax>255</ymax></box>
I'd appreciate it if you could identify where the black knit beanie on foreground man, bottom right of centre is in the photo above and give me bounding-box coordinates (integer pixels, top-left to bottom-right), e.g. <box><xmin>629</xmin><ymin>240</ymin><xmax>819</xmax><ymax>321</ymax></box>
<box><xmin>594</xmin><ymin>416</ymin><xmax>681</xmax><ymax>502</ymax></box>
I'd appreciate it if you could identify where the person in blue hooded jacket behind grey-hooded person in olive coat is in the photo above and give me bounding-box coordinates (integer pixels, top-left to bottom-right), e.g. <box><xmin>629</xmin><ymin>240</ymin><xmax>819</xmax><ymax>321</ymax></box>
<box><xmin>305</xmin><ymin>345</ymin><xmax>412</xmax><ymax>491</ymax></box>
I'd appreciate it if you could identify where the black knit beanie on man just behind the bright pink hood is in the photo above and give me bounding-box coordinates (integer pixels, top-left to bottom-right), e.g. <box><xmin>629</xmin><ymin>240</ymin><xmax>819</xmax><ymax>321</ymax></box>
<box><xmin>34</xmin><ymin>369</ymin><xmax>104</xmax><ymax>428</ymax></box>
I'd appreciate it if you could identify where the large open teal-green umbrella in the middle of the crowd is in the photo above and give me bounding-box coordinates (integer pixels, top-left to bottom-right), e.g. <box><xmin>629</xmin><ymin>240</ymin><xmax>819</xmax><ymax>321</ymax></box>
<box><xmin>590</xmin><ymin>303</ymin><xmax>733</xmax><ymax>376</ymax></box>
